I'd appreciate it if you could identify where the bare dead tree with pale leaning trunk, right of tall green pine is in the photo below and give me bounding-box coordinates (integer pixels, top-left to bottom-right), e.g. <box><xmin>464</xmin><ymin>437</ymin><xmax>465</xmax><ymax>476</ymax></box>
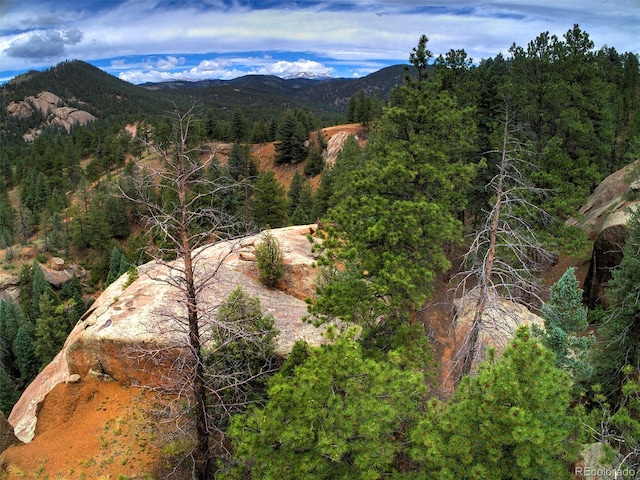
<box><xmin>454</xmin><ymin>100</ymin><xmax>552</xmax><ymax>375</ymax></box>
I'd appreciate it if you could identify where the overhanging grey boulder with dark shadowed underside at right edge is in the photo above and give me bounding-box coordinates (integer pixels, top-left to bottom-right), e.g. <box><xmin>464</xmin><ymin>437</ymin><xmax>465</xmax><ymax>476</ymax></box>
<box><xmin>568</xmin><ymin>161</ymin><xmax>640</xmax><ymax>308</ymax></box>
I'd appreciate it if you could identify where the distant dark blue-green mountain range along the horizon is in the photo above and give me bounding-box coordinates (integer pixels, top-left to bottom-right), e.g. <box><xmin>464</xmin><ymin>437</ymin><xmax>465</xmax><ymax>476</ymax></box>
<box><xmin>0</xmin><ymin>60</ymin><xmax>407</xmax><ymax>124</ymax></box>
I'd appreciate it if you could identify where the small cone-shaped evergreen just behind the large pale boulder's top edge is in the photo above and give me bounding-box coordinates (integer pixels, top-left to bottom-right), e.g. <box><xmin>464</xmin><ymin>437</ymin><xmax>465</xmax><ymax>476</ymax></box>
<box><xmin>251</xmin><ymin>170</ymin><xmax>289</xmax><ymax>228</ymax></box>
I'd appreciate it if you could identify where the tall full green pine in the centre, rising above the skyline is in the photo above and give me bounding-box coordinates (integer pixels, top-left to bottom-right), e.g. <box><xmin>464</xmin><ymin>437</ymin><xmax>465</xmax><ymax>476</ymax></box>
<box><xmin>313</xmin><ymin>34</ymin><xmax>474</xmax><ymax>338</ymax></box>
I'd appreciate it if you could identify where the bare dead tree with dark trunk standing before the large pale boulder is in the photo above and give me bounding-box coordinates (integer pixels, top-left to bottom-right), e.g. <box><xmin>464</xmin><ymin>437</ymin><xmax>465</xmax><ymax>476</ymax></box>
<box><xmin>120</xmin><ymin>106</ymin><xmax>271</xmax><ymax>480</ymax></box>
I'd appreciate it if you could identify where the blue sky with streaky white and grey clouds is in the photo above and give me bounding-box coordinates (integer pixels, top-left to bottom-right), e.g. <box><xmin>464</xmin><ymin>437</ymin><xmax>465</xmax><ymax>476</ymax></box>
<box><xmin>0</xmin><ymin>0</ymin><xmax>640</xmax><ymax>84</ymax></box>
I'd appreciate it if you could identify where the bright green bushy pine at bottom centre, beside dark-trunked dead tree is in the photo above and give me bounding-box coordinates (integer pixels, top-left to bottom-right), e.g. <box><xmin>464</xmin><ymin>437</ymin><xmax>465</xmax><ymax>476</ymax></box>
<box><xmin>229</xmin><ymin>332</ymin><xmax>426</xmax><ymax>479</ymax></box>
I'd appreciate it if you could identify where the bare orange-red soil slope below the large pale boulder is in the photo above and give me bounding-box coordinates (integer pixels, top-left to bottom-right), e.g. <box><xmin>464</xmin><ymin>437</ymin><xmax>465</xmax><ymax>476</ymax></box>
<box><xmin>0</xmin><ymin>378</ymin><xmax>162</xmax><ymax>480</ymax></box>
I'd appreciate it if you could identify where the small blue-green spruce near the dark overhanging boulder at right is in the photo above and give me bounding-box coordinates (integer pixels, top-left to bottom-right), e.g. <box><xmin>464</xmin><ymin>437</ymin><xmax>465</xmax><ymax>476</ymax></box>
<box><xmin>533</xmin><ymin>267</ymin><xmax>595</xmax><ymax>381</ymax></box>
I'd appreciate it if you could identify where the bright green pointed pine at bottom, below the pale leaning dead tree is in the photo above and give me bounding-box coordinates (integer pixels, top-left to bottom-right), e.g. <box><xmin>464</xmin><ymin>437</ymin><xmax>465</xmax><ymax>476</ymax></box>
<box><xmin>411</xmin><ymin>327</ymin><xmax>578</xmax><ymax>480</ymax></box>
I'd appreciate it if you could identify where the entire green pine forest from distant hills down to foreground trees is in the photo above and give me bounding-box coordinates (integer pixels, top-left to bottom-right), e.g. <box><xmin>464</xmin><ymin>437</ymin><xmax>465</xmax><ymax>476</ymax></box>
<box><xmin>0</xmin><ymin>25</ymin><xmax>640</xmax><ymax>480</ymax></box>
